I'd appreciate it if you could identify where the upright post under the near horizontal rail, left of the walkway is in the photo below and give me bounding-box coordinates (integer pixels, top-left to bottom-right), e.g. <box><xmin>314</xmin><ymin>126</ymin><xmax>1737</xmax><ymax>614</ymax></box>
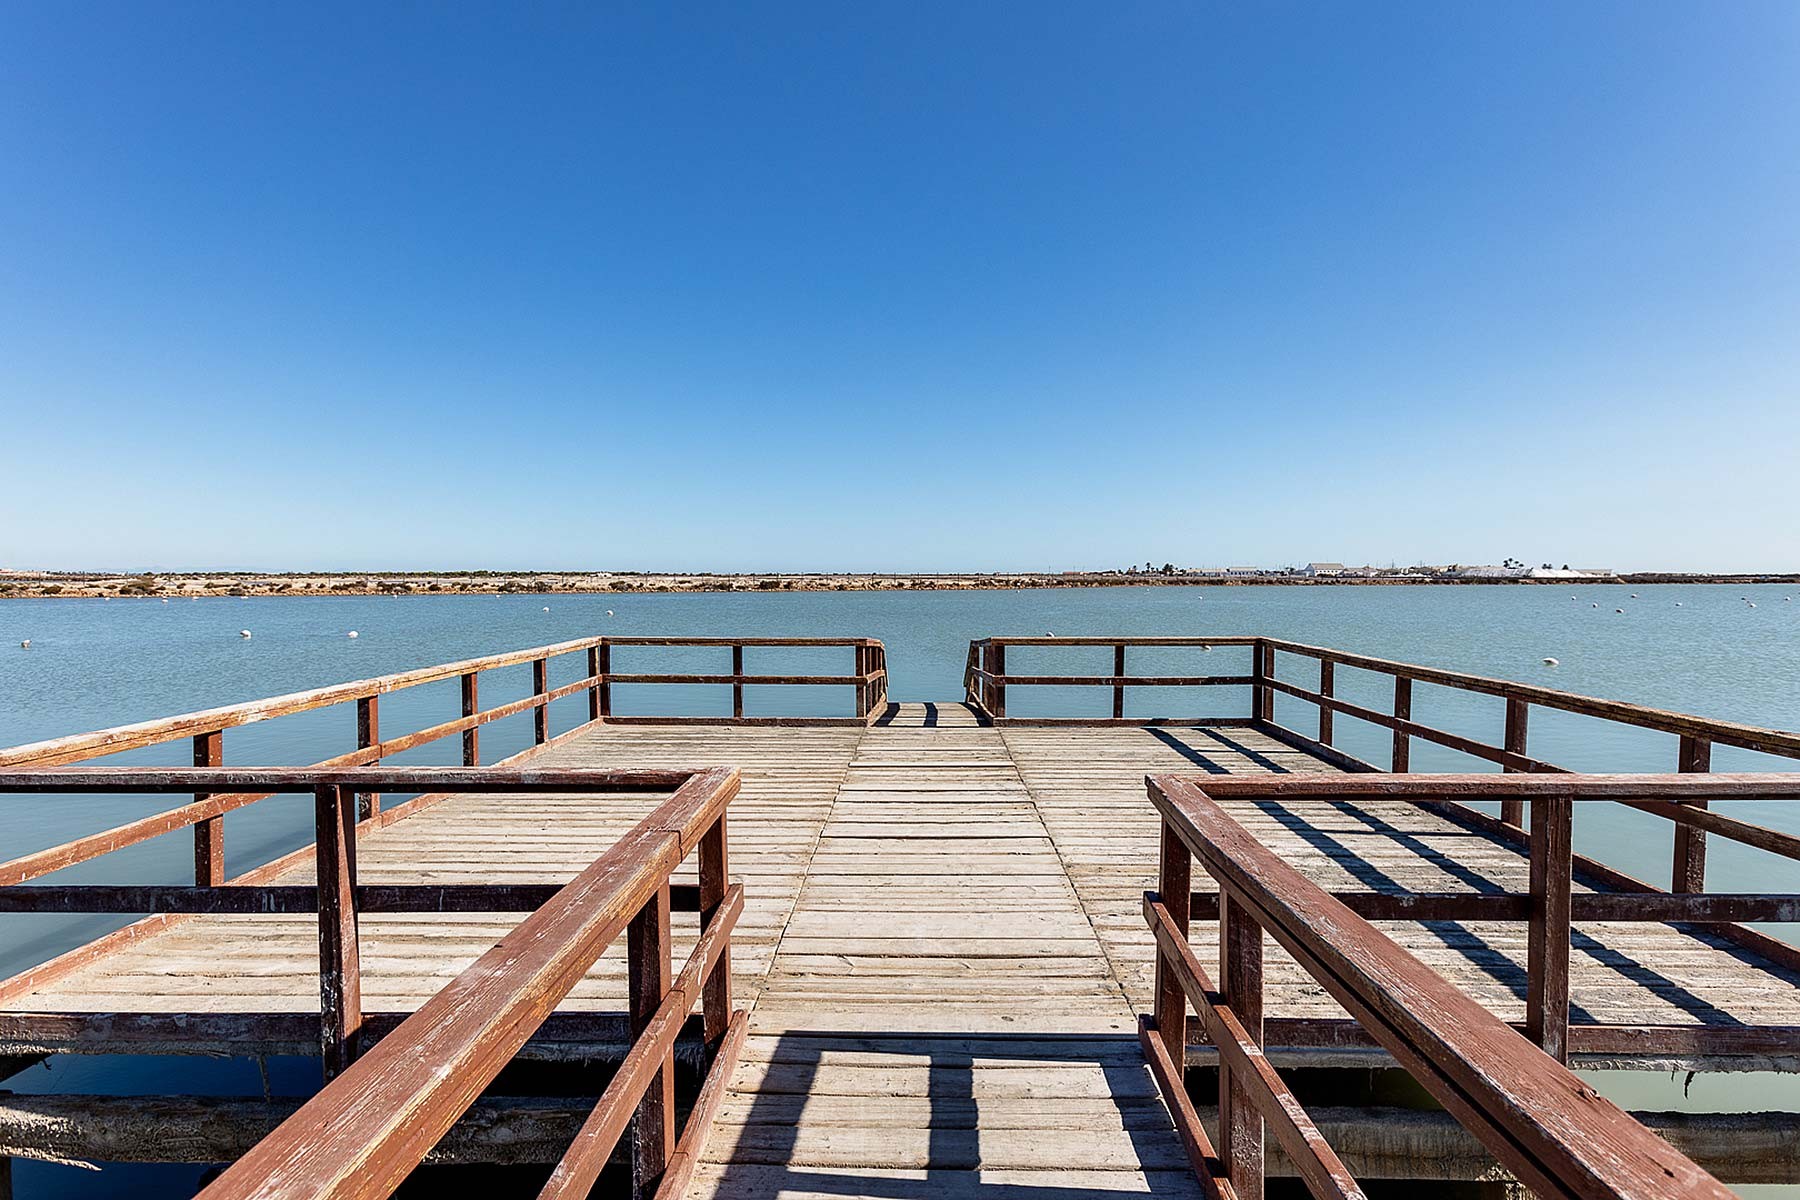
<box><xmin>313</xmin><ymin>784</ymin><xmax>362</xmax><ymax>1083</ymax></box>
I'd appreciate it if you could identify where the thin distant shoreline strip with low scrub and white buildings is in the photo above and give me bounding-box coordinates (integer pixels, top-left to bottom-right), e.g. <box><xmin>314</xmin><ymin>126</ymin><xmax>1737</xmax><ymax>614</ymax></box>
<box><xmin>0</xmin><ymin>570</ymin><xmax>1800</xmax><ymax>599</ymax></box>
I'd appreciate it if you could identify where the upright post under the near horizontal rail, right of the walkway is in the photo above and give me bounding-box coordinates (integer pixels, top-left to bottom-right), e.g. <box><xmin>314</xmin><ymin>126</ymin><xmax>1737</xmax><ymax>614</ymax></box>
<box><xmin>1525</xmin><ymin>792</ymin><xmax>1575</xmax><ymax>1061</ymax></box>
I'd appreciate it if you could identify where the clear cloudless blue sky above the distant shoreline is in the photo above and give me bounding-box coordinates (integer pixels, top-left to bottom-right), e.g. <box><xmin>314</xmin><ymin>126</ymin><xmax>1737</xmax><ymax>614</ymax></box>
<box><xmin>0</xmin><ymin>0</ymin><xmax>1800</xmax><ymax>570</ymax></box>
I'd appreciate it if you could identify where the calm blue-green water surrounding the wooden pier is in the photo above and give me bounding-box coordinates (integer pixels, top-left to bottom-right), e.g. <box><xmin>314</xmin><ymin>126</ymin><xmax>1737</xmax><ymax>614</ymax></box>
<box><xmin>0</xmin><ymin>585</ymin><xmax>1800</xmax><ymax>1196</ymax></box>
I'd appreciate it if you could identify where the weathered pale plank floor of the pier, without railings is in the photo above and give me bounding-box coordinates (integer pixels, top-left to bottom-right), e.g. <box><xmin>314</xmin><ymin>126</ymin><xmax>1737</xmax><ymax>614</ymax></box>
<box><xmin>4</xmin><ymin>703</ymin><xmax>1800</xmax><ymax>1196</ymax></box>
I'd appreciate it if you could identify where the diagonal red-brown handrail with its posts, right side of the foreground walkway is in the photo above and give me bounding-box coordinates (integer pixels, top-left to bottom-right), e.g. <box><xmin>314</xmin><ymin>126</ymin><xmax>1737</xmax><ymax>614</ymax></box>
<box><xmin>1139</xmin><ymin>775</ymin><xmax>1732</xmax><ymax>1200</ymax></box>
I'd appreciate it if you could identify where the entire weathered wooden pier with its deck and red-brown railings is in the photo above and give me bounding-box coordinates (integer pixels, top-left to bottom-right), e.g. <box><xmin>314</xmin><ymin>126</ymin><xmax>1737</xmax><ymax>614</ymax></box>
<box><xmin>0</xmin><ymin>639</ymin><xmax>1800</xmax><ymax>1200</ymax></box>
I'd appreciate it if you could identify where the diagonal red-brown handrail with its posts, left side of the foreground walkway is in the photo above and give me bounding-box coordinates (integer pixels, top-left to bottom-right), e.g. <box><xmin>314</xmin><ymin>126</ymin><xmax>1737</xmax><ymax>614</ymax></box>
<box><xmin>151</xmin><ymin>768</ymin><xmax>745</xmax><ymax>1200</ymax></box>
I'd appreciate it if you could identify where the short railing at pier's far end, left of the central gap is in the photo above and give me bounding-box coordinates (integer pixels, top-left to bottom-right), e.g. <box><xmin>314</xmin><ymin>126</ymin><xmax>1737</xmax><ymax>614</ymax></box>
<box><xmin>598</xmin><ymin>637</ymin><xmax>887</xmax><ymax>725</ymax></box>
